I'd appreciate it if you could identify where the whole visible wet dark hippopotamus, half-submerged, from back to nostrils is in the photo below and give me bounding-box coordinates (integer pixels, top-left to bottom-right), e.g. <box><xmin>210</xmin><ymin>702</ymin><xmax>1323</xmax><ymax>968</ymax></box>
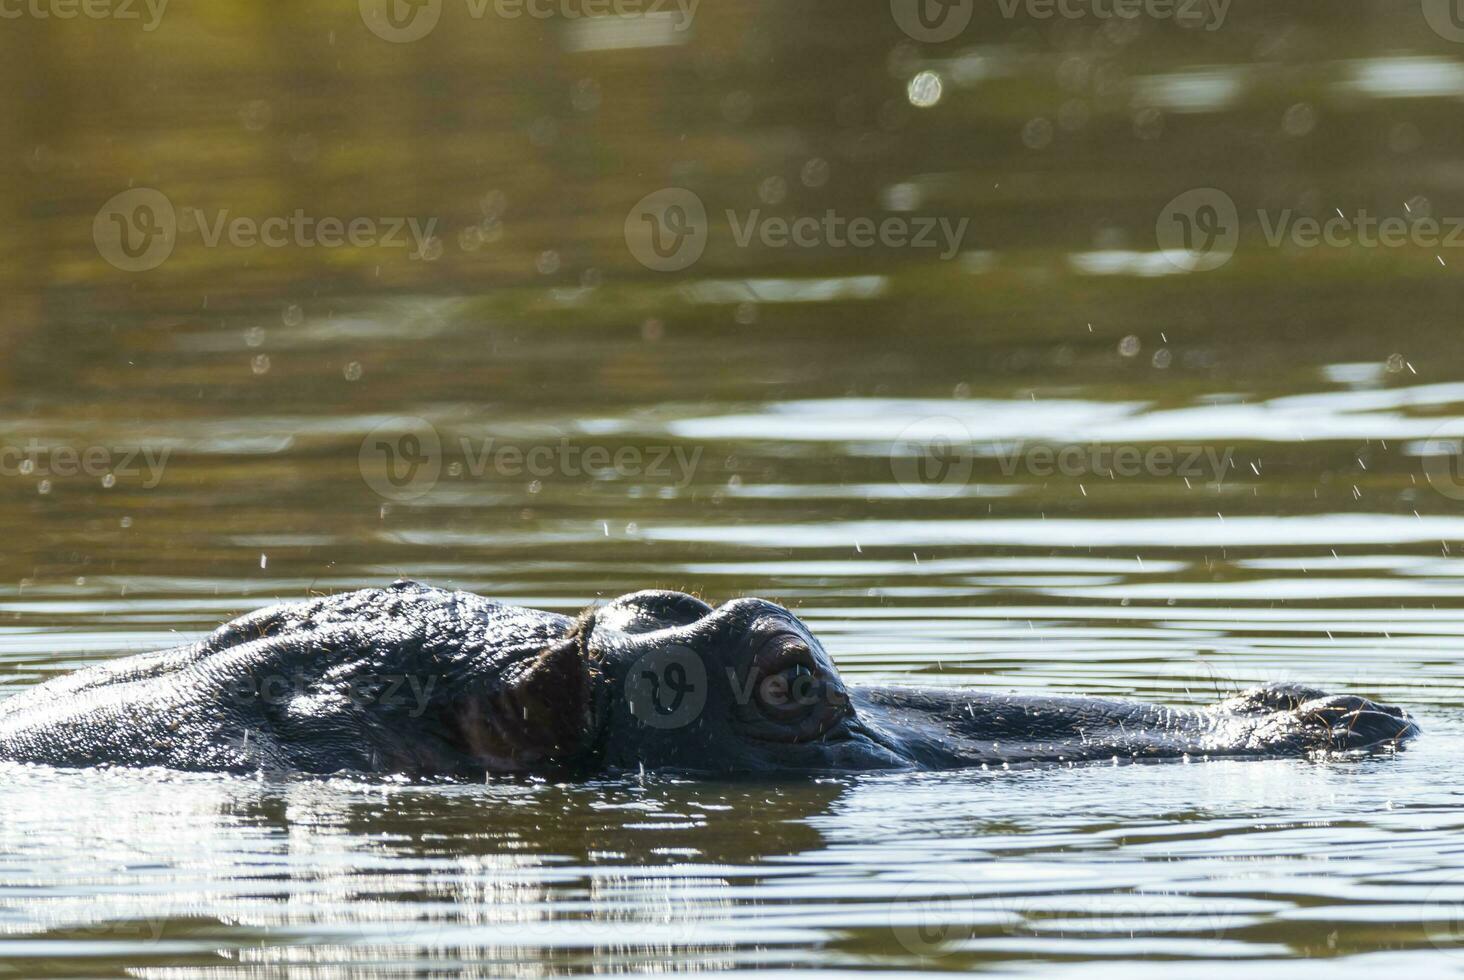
<box><xmin>0</xmin><ymin>582</ymin><xmax>1419</xmax><ymax>779</ymax></box>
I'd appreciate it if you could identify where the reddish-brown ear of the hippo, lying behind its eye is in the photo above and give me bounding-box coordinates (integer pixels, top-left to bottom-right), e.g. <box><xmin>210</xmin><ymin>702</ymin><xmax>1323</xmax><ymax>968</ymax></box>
<box><xmin>454</xmin><ymin>621</ymin><xmax>605</xmax><ymax>772</ymax></box>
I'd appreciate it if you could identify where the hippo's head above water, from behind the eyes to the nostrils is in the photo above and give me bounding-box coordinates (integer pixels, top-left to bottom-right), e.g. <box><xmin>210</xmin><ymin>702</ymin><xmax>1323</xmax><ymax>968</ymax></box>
<box><xmin>504</xmin><ymin>592</ymin><xmax>1417</xmax><ymax>773</ymax></box>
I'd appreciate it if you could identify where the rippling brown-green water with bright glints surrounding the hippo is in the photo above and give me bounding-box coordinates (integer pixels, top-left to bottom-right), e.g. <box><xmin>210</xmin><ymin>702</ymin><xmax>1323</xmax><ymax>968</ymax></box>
<box><xmin>0</xmin><ymin>0</ymin><xmax>1464</xmax><ymax>977</ymax></box>
